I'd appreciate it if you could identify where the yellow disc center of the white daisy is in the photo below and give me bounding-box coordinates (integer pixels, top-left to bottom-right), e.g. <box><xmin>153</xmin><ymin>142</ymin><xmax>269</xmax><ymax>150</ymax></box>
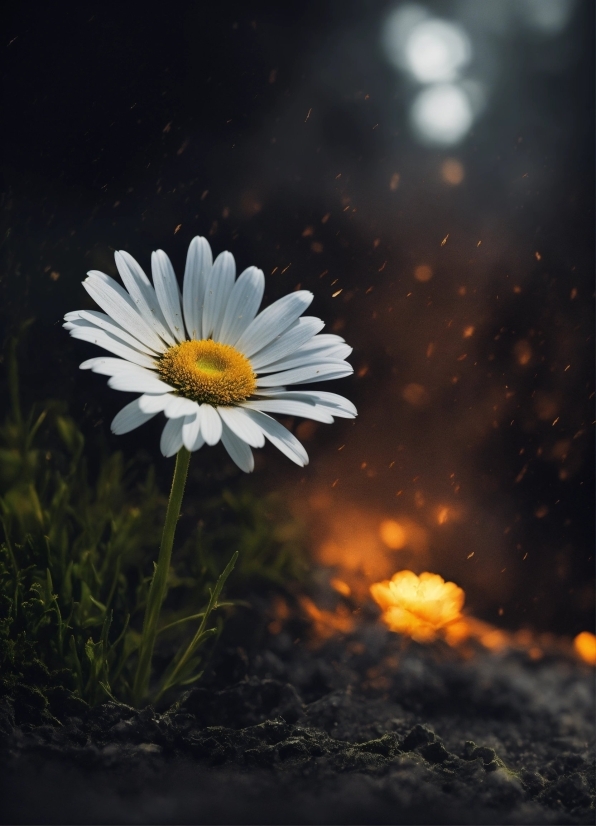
<box><xmin>158</xmin><ymin>339</ymin><xmax>257</xmax><ymax>406</ymax></box>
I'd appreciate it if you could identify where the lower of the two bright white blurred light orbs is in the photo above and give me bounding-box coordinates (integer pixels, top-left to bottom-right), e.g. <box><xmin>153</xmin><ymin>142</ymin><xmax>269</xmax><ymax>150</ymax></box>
<box><xmin>410</xmin><ymin>83</ymin><xmax>474</xmax><ymax>146</ymax></box>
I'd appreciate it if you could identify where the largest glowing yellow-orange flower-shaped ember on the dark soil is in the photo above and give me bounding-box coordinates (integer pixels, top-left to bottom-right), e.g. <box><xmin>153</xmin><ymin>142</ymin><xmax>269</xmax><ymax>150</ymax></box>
<box><xmin>370</xmin><ymin>571</ymin><xmax>465</xmax><ymax>642</ymax></box>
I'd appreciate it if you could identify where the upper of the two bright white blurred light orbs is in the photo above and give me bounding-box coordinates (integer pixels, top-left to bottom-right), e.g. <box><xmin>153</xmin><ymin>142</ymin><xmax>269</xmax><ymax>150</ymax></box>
<box><xmin>404</xmin><ymin>19</ymin><xmax>472</xmax><ymax>83</ymax></box>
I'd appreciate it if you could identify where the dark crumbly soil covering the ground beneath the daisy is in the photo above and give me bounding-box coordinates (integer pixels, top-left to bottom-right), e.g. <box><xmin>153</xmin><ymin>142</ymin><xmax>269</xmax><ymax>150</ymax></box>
<box><xmin>0</xmin><ymin>622</ymin><xmax>594</xmax><ymax>824</ymax></box>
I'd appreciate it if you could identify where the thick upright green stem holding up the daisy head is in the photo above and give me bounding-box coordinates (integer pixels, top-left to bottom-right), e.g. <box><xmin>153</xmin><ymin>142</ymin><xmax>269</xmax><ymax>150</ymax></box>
<box><xmin>133</xmin><ymin>447</ymin><xmax>190</xmax><ymax>706</ymax></box>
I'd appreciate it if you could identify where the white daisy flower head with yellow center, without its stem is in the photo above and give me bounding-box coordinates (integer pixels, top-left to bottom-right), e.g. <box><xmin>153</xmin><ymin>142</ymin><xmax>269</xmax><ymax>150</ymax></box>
<box><xmin>64</xmin><ymin>237</ymin><xmax>356</xmax><ymax>472</ymax></box>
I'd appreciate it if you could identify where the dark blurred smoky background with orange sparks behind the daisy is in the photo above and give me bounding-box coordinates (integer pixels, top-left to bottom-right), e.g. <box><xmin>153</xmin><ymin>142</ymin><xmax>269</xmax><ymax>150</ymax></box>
<box><xmin>0</xmin><ymin>0</ymin><xmax>594</xmax><ymax>635</ymax></box>
